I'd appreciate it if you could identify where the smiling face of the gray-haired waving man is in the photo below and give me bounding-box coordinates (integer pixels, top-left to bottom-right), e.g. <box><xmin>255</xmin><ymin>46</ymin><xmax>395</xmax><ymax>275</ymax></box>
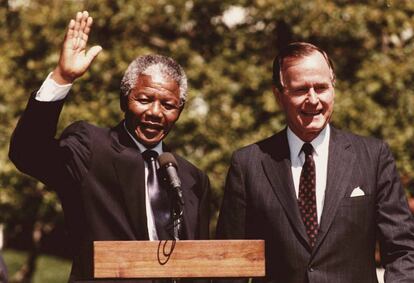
<box><xmin>125</xmin><ymin>74</ymin><xmax>182</xmax><ymax>148</ymax></box>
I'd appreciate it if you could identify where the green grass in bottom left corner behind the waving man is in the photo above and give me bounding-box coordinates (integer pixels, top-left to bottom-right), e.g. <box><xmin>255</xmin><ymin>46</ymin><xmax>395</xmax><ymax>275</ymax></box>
<box><xmin>2</xmin><ymin>250</ymin><xmax>71</xmax><ymax>283</ymax></box>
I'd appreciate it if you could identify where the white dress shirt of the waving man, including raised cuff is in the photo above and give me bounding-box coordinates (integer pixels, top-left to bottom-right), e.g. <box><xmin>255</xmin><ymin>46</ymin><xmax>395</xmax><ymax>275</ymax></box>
<box><xmin>35</xmin><ymin>73</ymin><xmax>163</xmax><ymax>241</ymax></box>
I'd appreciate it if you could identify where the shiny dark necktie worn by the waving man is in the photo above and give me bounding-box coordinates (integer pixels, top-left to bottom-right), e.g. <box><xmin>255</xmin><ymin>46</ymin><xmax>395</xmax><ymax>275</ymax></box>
<box><xmin>142</xmin><ymin>150</ymin><xmax>172</xmax><ymax>240</ymax></box>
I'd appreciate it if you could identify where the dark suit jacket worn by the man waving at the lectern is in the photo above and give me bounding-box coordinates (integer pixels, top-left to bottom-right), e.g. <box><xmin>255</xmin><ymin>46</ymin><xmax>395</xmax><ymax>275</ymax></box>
<box><xmin>9</xmin><ymin>97</ymin><xmax>209</xmax><ymax>282</ymax></box>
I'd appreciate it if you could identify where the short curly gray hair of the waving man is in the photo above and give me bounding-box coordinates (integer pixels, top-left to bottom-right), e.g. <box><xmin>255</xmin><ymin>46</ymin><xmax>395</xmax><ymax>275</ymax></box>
<box><xmin>120</xmin><ymin>55</ymin><xmax>187</xmax><ymax>107</ymax></box>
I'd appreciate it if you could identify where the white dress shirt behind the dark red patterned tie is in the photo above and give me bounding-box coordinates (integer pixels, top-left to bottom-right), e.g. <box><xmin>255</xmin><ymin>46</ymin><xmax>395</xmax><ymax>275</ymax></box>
<box><xmin>287</xmin><ymin>124</ymin><xmax>331</xmax><ymax>223</ymax></box>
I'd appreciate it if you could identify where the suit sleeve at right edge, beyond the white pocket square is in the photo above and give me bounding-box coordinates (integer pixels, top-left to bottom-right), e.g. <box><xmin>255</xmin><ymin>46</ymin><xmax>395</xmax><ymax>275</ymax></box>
<box><xmin>377</xmin><ymin>144</ymin><xmax>414</xmax><ymax>283</ymax></box>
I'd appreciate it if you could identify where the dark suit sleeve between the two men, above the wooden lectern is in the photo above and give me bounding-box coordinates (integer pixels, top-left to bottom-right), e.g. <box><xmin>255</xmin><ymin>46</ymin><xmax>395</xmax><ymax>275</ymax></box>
<box><xmin>217</xmin><ymin>153</ymin><xmax>246</xmax><ymax>239</ymax></box>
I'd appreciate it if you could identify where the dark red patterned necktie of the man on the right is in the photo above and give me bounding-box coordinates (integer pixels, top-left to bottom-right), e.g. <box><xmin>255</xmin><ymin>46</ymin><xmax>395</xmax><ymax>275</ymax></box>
<box><xmin>298</xmin><ymin>143</ymin><xmax>318</xmax><ymax>247</ymax></box>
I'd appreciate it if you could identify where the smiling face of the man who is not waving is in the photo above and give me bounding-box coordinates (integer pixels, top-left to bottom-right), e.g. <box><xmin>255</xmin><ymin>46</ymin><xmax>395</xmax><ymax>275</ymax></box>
<box><xmin>273</xmin><ymin>51</ymin><xmax>335</xmax><ymax>142</ymax></box>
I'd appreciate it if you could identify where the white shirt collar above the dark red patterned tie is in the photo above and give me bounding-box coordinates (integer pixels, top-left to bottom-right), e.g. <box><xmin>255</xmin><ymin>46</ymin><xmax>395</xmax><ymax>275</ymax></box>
<box><xmin>287</xmin><ymin>124</ymin><xmax>331</xmax><ymax>160</ymax></box>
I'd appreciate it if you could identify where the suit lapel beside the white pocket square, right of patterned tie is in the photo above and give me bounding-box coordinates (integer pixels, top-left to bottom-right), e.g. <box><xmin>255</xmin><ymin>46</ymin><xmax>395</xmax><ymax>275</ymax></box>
<box><xmin>314</xmin><ymin>127</ymin><xmax>356</xmax><ymax>251</ymax></box>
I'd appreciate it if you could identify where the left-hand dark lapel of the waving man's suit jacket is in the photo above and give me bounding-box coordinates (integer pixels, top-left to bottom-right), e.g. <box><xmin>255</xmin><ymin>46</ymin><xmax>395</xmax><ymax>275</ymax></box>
<box><xmin>112</xmin><ymin>122</ymin><xmax>148</xmax><ymax>239</ymax></box>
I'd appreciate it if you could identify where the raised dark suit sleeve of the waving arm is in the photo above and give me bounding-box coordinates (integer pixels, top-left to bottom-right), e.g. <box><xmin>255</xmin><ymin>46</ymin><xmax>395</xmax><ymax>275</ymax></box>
<box><xmin>9</xmin><ymin>95</ymin><xmax>90</xmax><ymax>192</ymax></box>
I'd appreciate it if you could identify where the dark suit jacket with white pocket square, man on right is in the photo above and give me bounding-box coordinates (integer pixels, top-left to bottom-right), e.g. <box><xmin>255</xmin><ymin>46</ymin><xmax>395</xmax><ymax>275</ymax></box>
<box><xmin>217</xmin><ymin>128</ymin><xmax>414</xmax><ymax>283</ymax></box>
